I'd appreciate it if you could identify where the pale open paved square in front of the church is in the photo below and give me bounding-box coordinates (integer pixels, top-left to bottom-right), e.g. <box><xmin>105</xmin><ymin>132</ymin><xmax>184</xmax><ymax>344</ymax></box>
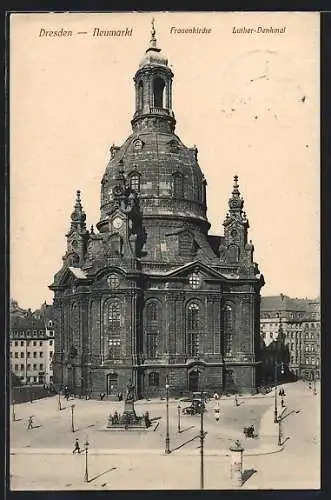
<box><xmin>10</xmin><ymin>382</ymin><xmax>320</xmax><ymax>490</ymax></box>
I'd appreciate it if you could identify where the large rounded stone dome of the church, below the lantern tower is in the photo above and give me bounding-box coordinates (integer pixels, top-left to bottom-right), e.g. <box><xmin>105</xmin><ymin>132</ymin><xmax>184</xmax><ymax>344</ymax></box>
<box><xmin>99</xmin><ymin>129</ymin><xmax>207</xmax><ymax>230</ymax></box>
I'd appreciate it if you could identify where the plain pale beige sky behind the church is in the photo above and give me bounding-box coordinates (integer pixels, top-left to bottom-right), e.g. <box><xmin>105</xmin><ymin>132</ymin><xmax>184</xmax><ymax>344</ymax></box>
<box><xmin>10</xmin><ymin>12</ymin><xmax>320</xmax><ymax>309</ymax></box>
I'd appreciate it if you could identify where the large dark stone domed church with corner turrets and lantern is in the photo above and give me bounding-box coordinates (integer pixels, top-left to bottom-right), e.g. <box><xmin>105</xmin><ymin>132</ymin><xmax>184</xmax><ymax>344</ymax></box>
<box><xmin>50</xmin><ymin>24</ymin><xmax>264</xmax><ymax>397</ymax></box>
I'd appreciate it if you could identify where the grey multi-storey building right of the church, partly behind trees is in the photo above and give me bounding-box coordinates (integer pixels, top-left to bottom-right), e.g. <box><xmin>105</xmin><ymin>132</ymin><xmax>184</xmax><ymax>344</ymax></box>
<box><xmin>261</xmin><ymin>294</ymin><xmax>320</xmax><ymax>379</ymax></box>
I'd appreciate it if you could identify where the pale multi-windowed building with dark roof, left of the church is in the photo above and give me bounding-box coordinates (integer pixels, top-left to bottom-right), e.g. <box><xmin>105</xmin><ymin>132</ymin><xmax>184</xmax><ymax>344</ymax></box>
<box><xmin>9</xmin><ymin>300</ymin><xmax>55</xmax><ymax>384</ymax></box>
